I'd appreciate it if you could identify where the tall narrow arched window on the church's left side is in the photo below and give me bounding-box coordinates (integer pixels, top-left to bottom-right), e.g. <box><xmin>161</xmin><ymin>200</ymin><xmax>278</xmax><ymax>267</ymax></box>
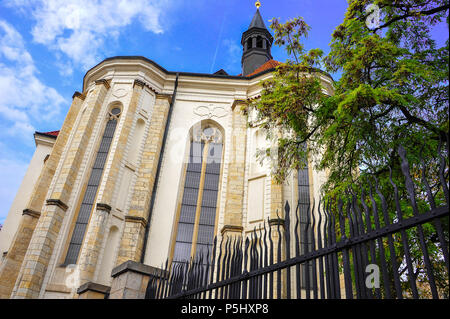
<box><xmin>64</xmin><ymin>108</ymin><xmax>120</xmax><ymax>265</ymax></box>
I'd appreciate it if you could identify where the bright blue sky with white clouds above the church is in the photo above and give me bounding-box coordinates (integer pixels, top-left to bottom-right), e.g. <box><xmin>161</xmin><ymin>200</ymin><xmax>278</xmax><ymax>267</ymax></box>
<box><xmin>0</xmin><ymin>0</ymin><xmax>442</xmax><ymax>224</ymax></box>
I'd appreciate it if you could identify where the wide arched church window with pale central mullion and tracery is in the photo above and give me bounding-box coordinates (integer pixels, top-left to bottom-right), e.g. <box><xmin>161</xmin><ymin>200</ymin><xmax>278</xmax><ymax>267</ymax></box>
<box><xmin>173</xmin><ymin>123</ymin><xmax>223</xmax><ymax>263</ymax></box>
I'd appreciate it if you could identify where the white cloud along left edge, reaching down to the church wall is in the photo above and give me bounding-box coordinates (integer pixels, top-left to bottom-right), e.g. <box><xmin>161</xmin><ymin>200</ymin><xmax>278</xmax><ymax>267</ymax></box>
<box><xmin>0</xmin><ymin>20</ymin><xmax>67</xmax><ymax>223</ymax></box>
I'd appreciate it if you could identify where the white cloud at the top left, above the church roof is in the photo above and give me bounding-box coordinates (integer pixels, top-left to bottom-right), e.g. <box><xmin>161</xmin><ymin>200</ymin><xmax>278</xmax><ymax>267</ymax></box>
<box><xmin>7</xmin><ymin>0</ymin><xmax>169</xmax><ymax>75</ymax></box>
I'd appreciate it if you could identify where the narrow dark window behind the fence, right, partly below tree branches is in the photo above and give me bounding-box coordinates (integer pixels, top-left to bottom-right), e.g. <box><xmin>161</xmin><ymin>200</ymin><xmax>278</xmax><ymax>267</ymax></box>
<box><xmin>297</xmin><ymin>145</ymin><xmax>313</xmax><ymax>287</ymax></box>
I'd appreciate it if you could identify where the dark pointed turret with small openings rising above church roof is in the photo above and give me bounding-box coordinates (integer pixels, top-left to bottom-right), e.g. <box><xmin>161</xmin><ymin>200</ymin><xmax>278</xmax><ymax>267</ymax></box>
<box><xmin>241</xmin><ymin>1</ymin><xmax>273</xmax><ymax>76</ymax></box>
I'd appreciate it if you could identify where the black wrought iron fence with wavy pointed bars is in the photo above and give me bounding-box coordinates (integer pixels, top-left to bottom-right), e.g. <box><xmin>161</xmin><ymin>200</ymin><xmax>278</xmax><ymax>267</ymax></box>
<box><xmin>146</xmin><ymin>147</ymin><xmax>449</xmax><ymax>299</ymax></box>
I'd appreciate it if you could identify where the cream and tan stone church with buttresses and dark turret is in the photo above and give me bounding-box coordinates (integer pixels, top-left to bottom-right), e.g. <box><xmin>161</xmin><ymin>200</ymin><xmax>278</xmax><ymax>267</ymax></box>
<box><xmin>0</xmin><ymin>2</ymin><xmax>333</xmax><ymax>298</ymax></box>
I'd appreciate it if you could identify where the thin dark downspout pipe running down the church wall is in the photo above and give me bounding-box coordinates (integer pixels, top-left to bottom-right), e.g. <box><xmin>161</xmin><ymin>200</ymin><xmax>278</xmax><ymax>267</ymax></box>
<box><xmin>141</xmin><ymin>72</ymin><xmax>179</xmax><ymax>264</ymax></box>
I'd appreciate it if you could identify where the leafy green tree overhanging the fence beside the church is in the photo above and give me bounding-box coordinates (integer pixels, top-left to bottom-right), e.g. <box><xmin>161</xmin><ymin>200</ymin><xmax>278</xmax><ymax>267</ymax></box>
<box><xmin>246</xmin><ymin>0</ymin><xmax>449</xmax><ymax>294</ymax></box>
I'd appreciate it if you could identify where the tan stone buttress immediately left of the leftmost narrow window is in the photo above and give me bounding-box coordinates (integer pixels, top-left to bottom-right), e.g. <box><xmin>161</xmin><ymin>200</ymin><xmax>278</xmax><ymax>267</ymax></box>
<box><xmin>12</xmin><ymin>81</ymin><xmax>109</xmax><ymax>298</ymax></box>
